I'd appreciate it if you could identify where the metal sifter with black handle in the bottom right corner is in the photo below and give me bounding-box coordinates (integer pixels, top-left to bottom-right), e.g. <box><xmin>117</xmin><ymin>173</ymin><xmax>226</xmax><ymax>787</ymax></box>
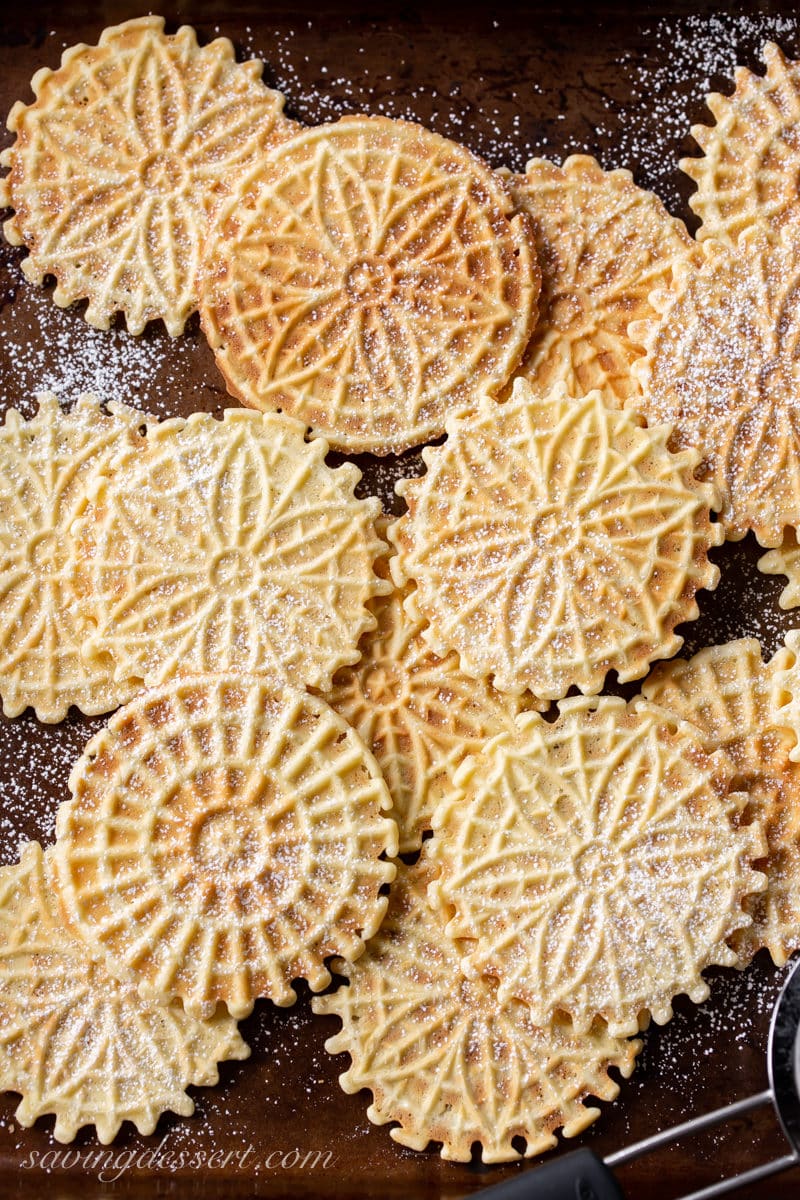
<box><xmin>479</xmin><ymin>960</ymin><xmax>800</xmax><ymax>1200</ymax></box>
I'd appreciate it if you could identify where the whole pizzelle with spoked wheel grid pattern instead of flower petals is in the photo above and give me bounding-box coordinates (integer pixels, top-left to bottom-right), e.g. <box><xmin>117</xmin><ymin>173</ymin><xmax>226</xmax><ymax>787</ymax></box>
<box><xmin>55</xmin><ymin>676</ymin><xmax>397</xmax><ymax>1018</ymax></box>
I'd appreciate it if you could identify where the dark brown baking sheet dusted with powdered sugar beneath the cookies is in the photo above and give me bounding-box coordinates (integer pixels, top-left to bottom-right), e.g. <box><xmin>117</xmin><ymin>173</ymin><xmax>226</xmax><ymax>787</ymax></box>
<box><xmin>0</xmin><ymin>0</ymin><xmax>800</xmax><ymax>1200</ymax></box>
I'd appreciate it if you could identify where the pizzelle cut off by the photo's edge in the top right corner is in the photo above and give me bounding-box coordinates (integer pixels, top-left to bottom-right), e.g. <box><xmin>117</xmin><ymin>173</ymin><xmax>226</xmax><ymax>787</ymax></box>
<box><xmin>680</xmin><ymin>42</ymin><xmax>800</xmax><ymax>246</ymax></box>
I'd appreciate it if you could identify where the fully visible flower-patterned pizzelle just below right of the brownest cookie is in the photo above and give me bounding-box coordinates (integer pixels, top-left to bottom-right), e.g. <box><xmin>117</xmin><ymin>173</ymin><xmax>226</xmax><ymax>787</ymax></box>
<box><xmin>390</xmin><ymin>379</ymin><xmax>722</xmax><ymax>700</ymax></box>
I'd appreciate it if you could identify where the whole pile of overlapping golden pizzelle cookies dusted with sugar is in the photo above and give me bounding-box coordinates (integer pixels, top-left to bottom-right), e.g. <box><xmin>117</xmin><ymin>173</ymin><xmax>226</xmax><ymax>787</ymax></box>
<box><xmin>0</xmin><ymin>9</ymin><xmax>800</xmax><ymax>1162</ymax></box>
